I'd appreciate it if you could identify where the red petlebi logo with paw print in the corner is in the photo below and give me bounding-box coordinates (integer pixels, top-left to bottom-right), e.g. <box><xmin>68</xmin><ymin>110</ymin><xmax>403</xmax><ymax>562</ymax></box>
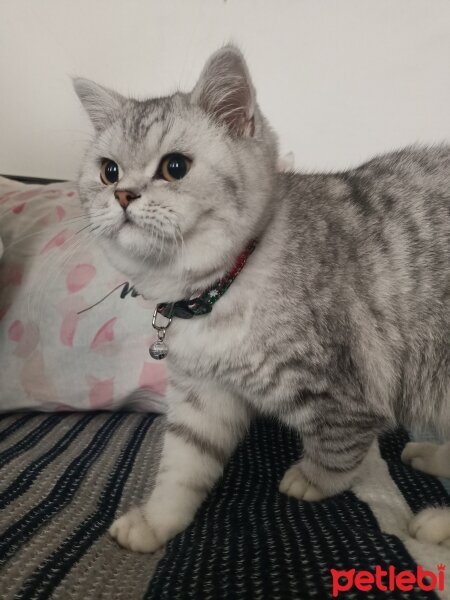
<box><xmin>330</xmin><ymin>565</ymin><xmax>445</xmax><ymax>598</ymax></box>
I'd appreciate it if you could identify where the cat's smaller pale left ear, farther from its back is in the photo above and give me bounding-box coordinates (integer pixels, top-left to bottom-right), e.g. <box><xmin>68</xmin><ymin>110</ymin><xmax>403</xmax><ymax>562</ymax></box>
<box><xmin>73</xmin><ymin>77</ymin><xmax>126</xmax><ymax>131</ymax></box>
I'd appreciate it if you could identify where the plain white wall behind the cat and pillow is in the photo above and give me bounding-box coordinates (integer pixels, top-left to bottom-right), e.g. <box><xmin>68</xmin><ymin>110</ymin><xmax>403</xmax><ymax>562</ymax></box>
<box><xmin>0</xmin><ymin>0</ymin><xmax>450</xmax><ymax>178</ymax></box>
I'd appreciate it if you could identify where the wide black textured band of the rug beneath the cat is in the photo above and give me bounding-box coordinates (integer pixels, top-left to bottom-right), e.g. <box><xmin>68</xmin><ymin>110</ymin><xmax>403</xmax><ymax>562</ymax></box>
<box><xmin>145</xmin><ymin>422</ymin><xmax>450</xmax><ymax>600</ymax></box>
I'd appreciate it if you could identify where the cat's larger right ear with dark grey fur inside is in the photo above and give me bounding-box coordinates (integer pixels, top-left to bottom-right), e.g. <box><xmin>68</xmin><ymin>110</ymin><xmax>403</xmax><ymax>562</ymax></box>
<box><xmin>191</xmin><ymin>46</ymin><xmax>255</xmax><ymax>137</ymax></box>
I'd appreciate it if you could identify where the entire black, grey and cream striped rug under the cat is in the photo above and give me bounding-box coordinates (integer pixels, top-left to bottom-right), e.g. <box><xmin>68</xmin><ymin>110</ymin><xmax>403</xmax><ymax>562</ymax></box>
<box><xmin>0</xmin><ymin>413</ymin><xmax>450</xmax><ymax>600</ymax></box>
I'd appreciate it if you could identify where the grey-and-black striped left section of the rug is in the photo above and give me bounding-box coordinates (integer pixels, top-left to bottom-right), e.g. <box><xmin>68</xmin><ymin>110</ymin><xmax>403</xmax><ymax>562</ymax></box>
<box><xmin>0</xmin><ymin>413</ymin><xmax>162</xmax><ymax>600</ymax></box>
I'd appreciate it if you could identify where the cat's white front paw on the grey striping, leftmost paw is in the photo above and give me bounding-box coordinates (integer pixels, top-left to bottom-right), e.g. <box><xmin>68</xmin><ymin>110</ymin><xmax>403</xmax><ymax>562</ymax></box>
<box><xmin>109</xmin><ymin>508</ymin><xmax>164</xmax><ymax>552</ymax></box>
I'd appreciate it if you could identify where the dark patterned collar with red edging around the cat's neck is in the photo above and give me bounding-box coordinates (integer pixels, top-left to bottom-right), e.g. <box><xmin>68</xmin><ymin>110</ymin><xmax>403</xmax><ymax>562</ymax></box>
<box><xmin>155</xmin><ymin>240</ymin><xmax>256</xmax><ymax>319</ymax></box>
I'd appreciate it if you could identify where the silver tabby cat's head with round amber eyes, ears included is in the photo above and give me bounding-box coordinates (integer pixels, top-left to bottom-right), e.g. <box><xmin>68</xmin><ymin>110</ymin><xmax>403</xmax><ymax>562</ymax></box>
<box><xmin>74</xmin><ymin>46</ymin><xmax>277</xmax><ymax>290</ymax></box>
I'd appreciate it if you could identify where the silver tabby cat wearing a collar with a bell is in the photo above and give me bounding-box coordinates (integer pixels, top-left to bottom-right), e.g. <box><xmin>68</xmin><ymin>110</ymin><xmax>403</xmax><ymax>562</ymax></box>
<box><xmin>74</xmin><ymin>46</ymin><xmax>450</xmax><ymax>552</ymax></box>
